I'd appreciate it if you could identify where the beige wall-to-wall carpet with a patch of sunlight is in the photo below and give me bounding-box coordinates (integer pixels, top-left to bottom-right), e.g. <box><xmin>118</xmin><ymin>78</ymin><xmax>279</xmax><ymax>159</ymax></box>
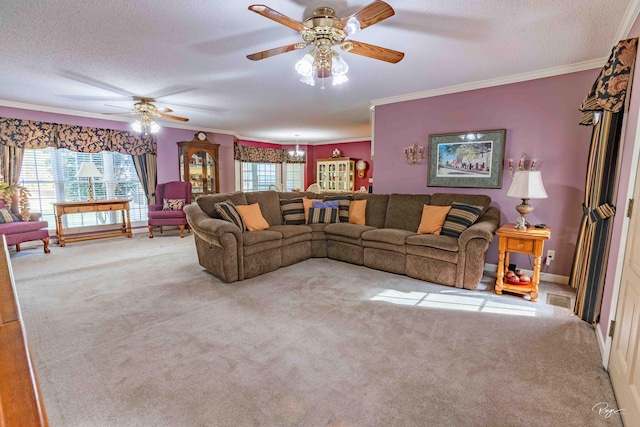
<box><xmin>12</xmin><ymin>231</ymin><xmax>621</xmax><ymax>427</ymax></box>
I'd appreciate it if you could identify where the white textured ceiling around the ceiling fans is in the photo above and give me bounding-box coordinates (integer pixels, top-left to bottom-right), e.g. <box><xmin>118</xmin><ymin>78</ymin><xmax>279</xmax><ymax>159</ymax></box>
<box><xmin>0</xmin><ymin>0</ymin><xmax>637</xmax><ymax>143</ymax></box>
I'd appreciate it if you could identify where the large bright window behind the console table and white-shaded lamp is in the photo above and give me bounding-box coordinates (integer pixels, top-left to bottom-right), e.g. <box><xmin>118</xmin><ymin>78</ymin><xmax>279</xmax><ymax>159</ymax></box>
<box><xmin>20</xmin><ymin>148</ymin><xmax>147</xmax><ymax>228</ymax></box>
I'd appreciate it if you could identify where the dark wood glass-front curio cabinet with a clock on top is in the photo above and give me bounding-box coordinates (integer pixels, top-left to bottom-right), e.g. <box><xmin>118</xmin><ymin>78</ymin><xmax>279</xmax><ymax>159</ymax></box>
<box><xmin>178</xmin><ymin>132</ymin><xmax>220</xmax><ymax>199</ymax></box>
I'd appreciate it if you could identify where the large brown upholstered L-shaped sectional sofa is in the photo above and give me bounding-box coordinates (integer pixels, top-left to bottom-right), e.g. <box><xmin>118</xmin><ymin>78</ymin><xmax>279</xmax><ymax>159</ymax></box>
<box><xmin>184</xmin><ymin>191</ymin><xmax>500</xmax><ymax>289</ymax></box>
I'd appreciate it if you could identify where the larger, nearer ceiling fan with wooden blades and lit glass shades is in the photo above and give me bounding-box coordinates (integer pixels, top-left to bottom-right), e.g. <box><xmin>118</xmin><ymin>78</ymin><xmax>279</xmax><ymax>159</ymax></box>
<box><xmin>247</xmin><ymin>0</ymin><xmax>404</xmax><ymax>89</ymax></box>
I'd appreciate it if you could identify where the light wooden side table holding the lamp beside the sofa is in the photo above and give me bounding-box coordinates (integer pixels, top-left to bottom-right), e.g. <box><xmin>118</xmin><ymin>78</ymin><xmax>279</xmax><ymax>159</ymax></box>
<box><xmin>495</xmin><ymin>224</ymin><xmax>551</xmax><ymax>302</ymax></box>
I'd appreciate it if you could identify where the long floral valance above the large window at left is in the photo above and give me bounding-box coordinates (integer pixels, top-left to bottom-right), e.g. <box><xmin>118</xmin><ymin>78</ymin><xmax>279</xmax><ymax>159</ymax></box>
<box><xmin>0</xmin><ymin>117</ymin><xmax>156</xmax><ymax>155</ymax></box>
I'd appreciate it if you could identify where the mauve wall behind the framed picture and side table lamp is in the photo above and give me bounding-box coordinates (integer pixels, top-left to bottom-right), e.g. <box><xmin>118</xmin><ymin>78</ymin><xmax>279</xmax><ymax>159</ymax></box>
<box><xmin>373</xmin><ymin>70</ymin><xmax>599</xmax><ymax>276</ymax></box>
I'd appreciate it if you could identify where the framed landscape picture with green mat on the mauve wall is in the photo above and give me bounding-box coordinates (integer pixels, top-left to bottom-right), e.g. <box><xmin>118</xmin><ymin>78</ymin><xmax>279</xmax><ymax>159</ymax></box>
<box><xmin>427</xmin><ymin>129</ymin><xmax>507</xmax><ymax>188</ymax></box>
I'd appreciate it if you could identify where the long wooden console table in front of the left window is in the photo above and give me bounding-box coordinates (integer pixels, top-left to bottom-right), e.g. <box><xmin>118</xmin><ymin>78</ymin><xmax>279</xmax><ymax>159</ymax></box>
<box><xmin>53</xmin><ymin>199</ymin><xmax>132</xmax><ymax>246</ymax></box>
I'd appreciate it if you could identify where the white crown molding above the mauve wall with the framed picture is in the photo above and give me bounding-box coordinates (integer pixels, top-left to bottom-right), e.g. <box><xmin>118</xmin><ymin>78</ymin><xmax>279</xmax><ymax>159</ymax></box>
<box><xmin>371</xmin><ymin>58</ymin><xmax>604</xmax><ymax>107</ymax></box>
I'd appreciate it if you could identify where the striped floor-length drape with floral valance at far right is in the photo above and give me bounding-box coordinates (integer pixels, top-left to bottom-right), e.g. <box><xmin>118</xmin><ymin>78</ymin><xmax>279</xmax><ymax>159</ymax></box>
<box><xmin>569</xmin><ymin>38</ymin><xmax>638</xmax><ymax>323</ymax></box>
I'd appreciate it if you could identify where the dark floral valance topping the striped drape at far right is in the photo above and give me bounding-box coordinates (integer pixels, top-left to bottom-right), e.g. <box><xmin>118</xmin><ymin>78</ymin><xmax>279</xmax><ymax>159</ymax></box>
<box><xmin>580</xmin><ymin>37</ymin><xmax>638</xmax><ymax>126</ymax></box>
